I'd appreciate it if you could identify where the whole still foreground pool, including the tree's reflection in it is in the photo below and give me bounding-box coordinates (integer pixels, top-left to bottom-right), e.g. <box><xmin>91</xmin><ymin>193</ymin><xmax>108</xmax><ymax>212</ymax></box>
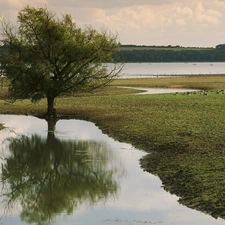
<box><xmin>0</xmin><ymin>115</ymin><xmax>224</xmax><ymax>225</ymax></box>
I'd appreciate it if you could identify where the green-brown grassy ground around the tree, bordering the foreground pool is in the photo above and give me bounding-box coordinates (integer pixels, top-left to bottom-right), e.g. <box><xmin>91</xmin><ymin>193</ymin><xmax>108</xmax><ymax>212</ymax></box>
<box><xmin>0</xmin><ymin>76</ymin><xmax>225</xmax><ymax>219</ymax></box>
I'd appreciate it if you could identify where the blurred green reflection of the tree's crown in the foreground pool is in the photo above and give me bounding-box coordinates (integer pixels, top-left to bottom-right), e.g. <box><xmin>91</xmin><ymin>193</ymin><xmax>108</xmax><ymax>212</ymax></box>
<box><xmin>1</xmin><ymin>120</ymin><xmax>122</xmax><ymax>224</ymax></box>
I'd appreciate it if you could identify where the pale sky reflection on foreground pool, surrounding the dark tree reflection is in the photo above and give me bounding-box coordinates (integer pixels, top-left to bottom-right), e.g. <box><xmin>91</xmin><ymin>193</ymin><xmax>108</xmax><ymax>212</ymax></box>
<box><xmin>0</xmin><ymin>115</ymin><xmax>224</xmax><ymax>225</ymax></box>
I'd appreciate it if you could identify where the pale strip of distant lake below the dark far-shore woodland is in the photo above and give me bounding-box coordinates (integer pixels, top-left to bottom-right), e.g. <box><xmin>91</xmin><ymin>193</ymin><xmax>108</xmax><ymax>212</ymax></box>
<box><xmin>121</xmin><ymin>62</ymin><xmax>225</xmax><ymax>78</ymax></box>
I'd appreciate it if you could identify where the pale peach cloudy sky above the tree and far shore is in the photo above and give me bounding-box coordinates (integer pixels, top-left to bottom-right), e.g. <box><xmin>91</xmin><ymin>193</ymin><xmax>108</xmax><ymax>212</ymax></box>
<box><xmin>0</xmin><ymin>0</ymin><xmax>225</xmax><ymax>47</ymax></box>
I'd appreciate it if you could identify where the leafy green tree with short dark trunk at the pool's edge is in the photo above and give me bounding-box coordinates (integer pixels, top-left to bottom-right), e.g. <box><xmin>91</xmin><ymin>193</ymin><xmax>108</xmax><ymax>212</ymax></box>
<box><xmin>0</xmin><ymin>6</ymin><xmax>122</xmax><ymax>117</ymax></box>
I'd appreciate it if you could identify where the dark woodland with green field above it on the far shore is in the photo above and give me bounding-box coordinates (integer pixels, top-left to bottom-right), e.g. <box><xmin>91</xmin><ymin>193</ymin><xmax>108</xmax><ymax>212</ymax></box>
<box><xmin>113</xmin><ymin>44</ymin><xmax>225</xmax><ymax>62</ymax></box>
